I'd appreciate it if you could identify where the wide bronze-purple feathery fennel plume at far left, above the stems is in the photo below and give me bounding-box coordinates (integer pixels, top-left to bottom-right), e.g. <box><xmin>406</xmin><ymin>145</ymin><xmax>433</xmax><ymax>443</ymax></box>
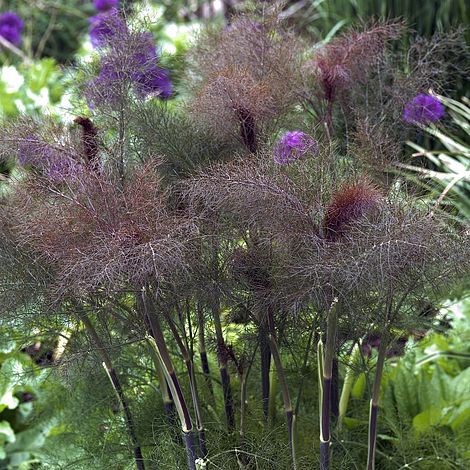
<box><xmin>4</xmin><ymin>160</ymin><xmax>194</xmax><ymax>298</ymax></box>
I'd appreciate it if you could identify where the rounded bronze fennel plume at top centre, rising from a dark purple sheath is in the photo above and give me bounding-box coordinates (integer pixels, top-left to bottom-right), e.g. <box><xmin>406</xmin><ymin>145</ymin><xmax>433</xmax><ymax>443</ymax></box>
<box><xmin>188</xmin><ymin>13</ymin><xmax>302</xmax><ymax>152</ymax></box>
